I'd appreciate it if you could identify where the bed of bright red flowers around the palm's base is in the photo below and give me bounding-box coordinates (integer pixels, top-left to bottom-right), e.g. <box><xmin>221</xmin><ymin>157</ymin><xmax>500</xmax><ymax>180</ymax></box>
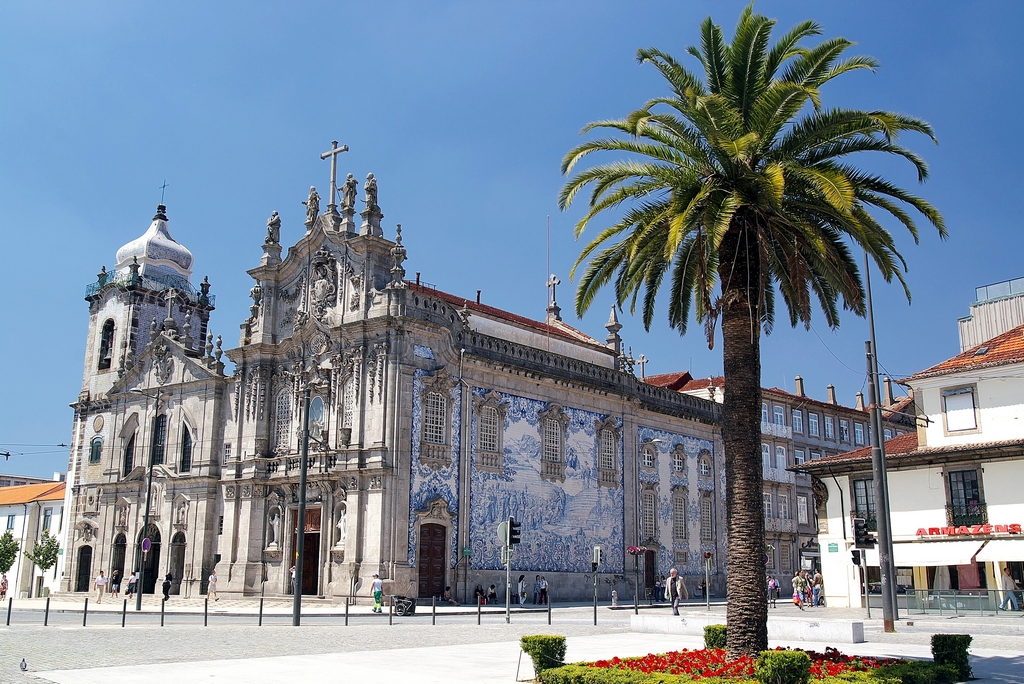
<box><xmin>590</xmin><ymin>648</ymin><xmax>906</xmax><ymax>680</ymax></box>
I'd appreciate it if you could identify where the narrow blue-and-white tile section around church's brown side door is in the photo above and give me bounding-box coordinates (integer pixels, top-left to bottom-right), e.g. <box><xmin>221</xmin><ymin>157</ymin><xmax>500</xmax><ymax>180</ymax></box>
<box><xmin>409</xmin><ymin>366</ymin><xmax>462</xmax><ymax>567</ymax></box>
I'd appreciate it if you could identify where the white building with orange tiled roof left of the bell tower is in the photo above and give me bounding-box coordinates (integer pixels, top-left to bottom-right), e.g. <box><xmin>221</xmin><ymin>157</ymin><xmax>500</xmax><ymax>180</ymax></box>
<box><xmin>0</xmin><ymin>482</ymin><xmax>65</xmax><ymax>598</ymax></box>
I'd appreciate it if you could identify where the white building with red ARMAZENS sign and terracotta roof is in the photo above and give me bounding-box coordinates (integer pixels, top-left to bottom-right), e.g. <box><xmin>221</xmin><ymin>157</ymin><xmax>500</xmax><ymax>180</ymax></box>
<box><xmin>797</xmin><ymin>326</ymin><xmax>1024</xmax><ymax>609</ymax></box>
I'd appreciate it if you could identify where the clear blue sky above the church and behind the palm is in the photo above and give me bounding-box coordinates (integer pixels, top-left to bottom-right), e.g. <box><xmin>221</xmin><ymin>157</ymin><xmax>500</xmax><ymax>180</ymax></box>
<box><xmin>0</xmin><ymin>0</ymin><xmax>1024</xmax><ymax>476</ymax></box>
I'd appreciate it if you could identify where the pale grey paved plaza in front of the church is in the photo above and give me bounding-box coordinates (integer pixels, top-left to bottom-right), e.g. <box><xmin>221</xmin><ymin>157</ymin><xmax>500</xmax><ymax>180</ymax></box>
<box><xmin>0</xmin><ymin>597</ymin><xmax>1024</xmax><ymax>684</ymax></box>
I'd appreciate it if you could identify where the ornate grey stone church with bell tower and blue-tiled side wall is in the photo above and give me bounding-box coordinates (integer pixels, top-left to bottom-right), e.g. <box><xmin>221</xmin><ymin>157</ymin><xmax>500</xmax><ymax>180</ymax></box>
<box><xmin>61</xmin><ymin>162</ymin><xmax>725</xmax><ymax>600</ymax></box>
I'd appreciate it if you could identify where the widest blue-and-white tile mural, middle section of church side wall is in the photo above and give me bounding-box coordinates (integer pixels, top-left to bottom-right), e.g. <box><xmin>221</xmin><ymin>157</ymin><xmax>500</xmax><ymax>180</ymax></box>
<box><xmin>469</xmin><ymin>387</ymin><xmax>624</xmax><ymax>572</ymax></box>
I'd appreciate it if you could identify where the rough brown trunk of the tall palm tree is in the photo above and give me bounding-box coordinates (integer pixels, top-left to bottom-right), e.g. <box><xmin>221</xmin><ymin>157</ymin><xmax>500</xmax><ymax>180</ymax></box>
<box><xmin>719</xmin><ymin>216</ymin><xmax>768</xmax><ymax>658</ymax></box>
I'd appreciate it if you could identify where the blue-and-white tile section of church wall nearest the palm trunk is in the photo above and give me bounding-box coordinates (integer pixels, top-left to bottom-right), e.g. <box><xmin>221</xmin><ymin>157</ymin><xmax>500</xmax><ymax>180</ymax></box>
<box><xmin>637</xmin><ymin>426</ymin><xmax>725</xmax><ymax>574</ymax></box>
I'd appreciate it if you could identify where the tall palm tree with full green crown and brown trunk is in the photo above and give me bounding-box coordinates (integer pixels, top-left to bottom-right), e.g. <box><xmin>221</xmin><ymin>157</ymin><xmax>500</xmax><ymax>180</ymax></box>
<box><xmin>559</xmin><ymin>6</ymin><xmax>946</xmax><ymax>657</ymax></box>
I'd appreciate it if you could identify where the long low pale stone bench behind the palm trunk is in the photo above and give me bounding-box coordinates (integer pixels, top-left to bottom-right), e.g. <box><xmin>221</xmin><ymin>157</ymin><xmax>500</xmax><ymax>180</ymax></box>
<box><xmin>630</xmin><ymin>614</ymin><xmax>864</xmax><ymax>644</ymax></box>
